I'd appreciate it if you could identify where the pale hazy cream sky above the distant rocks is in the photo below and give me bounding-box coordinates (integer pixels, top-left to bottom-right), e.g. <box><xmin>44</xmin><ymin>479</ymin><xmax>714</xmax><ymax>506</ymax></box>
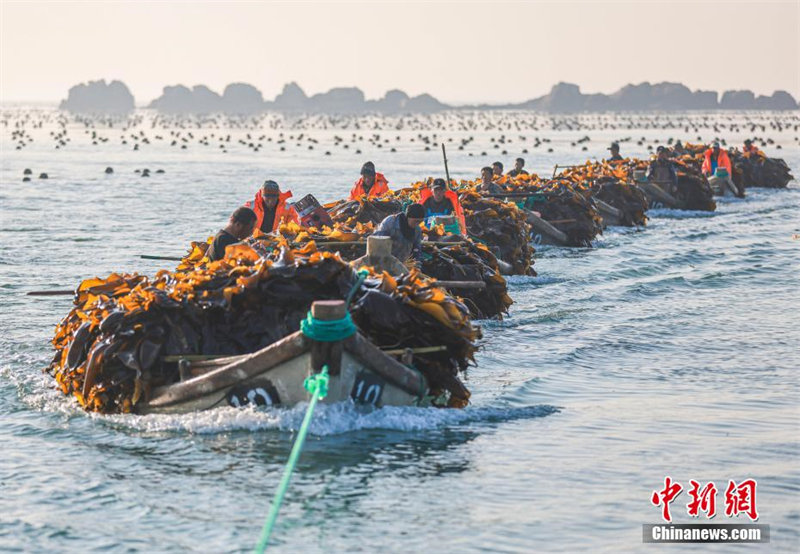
<box><xmin>0</xmin><ymin>0</ymin><xmax>800</xmax><ymax>104</ymax></box>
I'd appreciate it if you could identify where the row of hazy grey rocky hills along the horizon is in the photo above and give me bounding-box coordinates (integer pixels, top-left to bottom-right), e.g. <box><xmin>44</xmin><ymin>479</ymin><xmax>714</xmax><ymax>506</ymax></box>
<box><xmin>61</xmin><ymin>81</ymin><xmax>798</xmax><ymax>115</ymax></box>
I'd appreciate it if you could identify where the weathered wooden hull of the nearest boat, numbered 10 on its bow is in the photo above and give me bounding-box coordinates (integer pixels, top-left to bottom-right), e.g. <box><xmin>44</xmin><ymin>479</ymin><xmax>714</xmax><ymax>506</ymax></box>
<box><xmin>137</xmin><ymin>301</ymin><xmax>424</xmax><ymax>414</ymax></box>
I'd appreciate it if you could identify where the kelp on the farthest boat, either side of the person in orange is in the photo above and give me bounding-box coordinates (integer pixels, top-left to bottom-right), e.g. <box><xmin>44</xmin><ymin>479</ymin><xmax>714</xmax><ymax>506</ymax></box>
<box><xmin>673</xmin><ymin>144</ymin><xmax>794</xmax><ymax>190</ymax></box>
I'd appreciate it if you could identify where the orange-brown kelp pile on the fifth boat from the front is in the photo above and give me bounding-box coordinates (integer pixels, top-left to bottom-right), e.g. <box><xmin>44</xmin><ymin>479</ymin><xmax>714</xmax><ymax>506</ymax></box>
<box><xmin>557</xmin><ymin>162</ymin><xmax>648</xmax><ymax>227</ymax></box>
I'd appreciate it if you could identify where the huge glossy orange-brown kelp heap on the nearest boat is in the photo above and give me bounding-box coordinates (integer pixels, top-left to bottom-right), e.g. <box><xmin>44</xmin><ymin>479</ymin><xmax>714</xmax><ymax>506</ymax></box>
<box><xmin>48</xmin><ymin>244</ymin><xmax>480</xmax><ymax>413</ymax></box>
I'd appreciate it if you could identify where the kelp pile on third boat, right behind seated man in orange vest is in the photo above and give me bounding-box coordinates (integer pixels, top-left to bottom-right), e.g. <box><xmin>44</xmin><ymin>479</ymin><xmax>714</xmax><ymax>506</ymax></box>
<box><xmin>459</xmin><ymin>190</ymin><xmax>536</xmax><ymax>275</ymax></box>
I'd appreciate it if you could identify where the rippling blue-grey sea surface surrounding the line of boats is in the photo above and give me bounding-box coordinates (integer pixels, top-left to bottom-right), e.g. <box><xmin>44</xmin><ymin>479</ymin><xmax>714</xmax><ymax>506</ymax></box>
<box><xmin>0</xmin><ymin>109</ymin><xmax>800</xmax><ymax>554</ymax></box>
